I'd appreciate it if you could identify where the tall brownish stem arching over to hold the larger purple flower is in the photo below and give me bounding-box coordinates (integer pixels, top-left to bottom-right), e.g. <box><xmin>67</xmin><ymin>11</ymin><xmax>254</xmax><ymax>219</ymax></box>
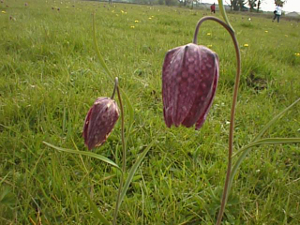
<box><xmin>193</xmin><ymin>16</ymin><xmax>241</xmax><ymax>225</ymax></box>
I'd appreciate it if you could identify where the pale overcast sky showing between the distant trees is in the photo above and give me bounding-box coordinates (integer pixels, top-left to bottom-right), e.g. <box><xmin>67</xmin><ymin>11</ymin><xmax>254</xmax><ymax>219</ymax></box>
<box><xmin>200</xmin><ymin>0</ymin><xmax>300</xmax><ymax>12</ymax></box>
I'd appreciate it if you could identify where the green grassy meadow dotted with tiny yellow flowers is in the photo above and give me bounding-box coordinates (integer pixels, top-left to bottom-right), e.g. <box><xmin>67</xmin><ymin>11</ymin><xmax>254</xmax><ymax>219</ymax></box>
<box><xmin>0</xmin><ymin>0</ymin><xmax>300</xmax><ymax>225</ymax></box>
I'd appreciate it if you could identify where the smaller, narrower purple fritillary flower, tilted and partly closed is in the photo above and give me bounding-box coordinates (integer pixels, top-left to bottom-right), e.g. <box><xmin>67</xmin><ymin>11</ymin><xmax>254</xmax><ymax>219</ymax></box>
<box><xmin>83</xmin><ymin>97</ymin><xmax>120</xmax><ymax>150</ymax></box>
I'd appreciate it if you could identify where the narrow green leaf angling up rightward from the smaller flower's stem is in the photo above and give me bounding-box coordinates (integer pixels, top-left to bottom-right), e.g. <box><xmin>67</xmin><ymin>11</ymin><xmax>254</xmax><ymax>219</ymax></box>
<box><xmin>118</xmin><ymin>139</ymin><xmax>156</xmax><ymax>208</ymax></box>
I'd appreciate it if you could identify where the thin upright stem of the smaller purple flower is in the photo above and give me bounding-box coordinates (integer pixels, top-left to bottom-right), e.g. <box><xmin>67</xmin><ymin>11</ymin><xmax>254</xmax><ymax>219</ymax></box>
<box><xmin>113</xmin><ymin>77</ymin><xmax>126</xmax><ymax>225</ymax></box>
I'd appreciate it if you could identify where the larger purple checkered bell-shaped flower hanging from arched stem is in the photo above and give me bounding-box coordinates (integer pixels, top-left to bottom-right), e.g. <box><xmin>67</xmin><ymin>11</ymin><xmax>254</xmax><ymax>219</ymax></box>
<box><xmin>162</xmin><ymin>43</ymin><xmax>219</xmax><ymax>130</ymax></box>
